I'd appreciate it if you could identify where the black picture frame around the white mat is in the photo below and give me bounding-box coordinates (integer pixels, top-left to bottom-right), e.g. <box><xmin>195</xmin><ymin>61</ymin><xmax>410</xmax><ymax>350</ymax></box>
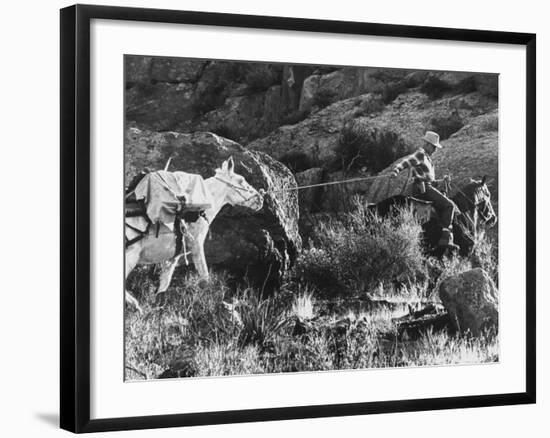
<box><xmin>60</xmin><ymin>5</ymin><xmax>536</xmax><ymax>433</ymax></box>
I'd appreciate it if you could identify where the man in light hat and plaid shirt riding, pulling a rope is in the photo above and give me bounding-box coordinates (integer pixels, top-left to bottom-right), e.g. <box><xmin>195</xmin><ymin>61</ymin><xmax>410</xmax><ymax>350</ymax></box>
<box><xmin>392</xmin><ymin>131</ymin><xmax>456</xmax><ymax>247</ymax></box>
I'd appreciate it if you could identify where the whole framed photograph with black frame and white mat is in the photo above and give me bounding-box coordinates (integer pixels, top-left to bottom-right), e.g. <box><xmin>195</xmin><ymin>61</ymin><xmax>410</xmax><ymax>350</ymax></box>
<box><xmin>60</xmin><ymin>5</ymin><xmax>536</xmax><ymax>432</ymax></box>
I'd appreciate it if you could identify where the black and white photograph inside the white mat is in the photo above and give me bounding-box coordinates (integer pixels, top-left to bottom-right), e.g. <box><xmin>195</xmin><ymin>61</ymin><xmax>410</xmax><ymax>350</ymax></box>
<box><xmin>126</xmin><ymin>54</ymin><xmax>501</xmax><ymax>381</ymax></box>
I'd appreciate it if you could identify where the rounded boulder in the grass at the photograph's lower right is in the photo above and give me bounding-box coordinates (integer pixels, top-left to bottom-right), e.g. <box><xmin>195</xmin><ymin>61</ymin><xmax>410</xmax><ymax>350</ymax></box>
<box><xmin>439</xmin><ymin>268</ymin><xmax>498</xmax><ymax>336</ymax></box>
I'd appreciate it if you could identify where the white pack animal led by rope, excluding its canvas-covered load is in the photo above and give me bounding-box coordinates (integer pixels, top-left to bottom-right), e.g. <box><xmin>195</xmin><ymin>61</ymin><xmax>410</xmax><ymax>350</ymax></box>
<box><xmin>125</xmin><ymin>157</ymin><xmax>264</xmax><ymax>314</ymax></box>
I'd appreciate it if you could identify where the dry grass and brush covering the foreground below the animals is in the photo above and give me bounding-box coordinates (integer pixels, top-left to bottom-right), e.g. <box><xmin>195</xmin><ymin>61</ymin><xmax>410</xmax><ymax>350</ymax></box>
<box><xmin>125</xmin><ymin>205</ymin><xmax>498</xmax><ymax>379</ymax></box>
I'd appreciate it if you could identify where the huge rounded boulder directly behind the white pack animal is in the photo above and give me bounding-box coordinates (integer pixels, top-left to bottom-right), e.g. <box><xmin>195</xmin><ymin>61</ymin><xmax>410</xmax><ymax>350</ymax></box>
<box><xmin>124</xmin><ymin>128</ymin><xmax>301</xmax><ymax>289</ymax></box>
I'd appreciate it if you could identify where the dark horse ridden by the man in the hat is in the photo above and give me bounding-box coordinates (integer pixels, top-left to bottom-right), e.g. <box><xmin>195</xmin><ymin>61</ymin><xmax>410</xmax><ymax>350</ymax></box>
<box><xmin>369</xmin><ymin>176</ymin><xmax>497</xmax><ymax>256</ymax></box>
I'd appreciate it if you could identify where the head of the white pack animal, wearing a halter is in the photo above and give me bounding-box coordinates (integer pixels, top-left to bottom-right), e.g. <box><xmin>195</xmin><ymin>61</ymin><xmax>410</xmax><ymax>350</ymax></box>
<box><xmin>215</xmin><ymin>157</ymin><xmax>264</xmax><ymax>211</ymax></box>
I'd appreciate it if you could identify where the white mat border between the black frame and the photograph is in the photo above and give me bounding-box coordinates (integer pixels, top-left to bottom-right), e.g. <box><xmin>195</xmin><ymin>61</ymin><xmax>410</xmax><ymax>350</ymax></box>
<box><xmin>90</xmin><ymin>20</ymin><xmax>525</xmax><ymax>418</ymax></box>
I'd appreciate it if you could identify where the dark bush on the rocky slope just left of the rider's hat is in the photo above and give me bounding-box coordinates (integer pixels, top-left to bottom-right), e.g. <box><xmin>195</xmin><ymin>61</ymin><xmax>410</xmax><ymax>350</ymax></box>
<box><xmin>335</xmin><ymin>118</ymin><xmax>413</xmax><ymax>172</ymax></box>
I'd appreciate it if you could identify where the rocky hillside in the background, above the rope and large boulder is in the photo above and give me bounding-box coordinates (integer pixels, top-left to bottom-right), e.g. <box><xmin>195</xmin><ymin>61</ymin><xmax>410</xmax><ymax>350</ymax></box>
<box><xmin>125</xmin><ymin>56</ymin><xmax>498</xmax><ymax>222</ymax></box>
